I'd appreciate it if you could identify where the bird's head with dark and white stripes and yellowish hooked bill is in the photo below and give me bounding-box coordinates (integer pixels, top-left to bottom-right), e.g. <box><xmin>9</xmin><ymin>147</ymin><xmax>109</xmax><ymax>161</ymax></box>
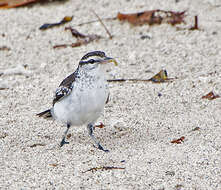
<box><xmin>79</xmin><ymin>51</ymin><xmax>117</xmax><ymax>69</ymax></box>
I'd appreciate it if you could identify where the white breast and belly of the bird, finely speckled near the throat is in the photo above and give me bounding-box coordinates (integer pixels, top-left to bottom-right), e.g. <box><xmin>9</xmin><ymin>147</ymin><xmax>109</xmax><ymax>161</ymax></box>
<box><xmin>52</xmin><ymin>65</ymin><xmax>109</xmax><ymax>126</ymax></box>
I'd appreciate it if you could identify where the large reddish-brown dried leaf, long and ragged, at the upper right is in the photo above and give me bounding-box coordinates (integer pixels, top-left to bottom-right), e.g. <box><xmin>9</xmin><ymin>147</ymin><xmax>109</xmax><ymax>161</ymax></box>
<box><xmin>117</xmin><ymin>10</ymin><xmax>185</xmax><ymax>25</ymax></box>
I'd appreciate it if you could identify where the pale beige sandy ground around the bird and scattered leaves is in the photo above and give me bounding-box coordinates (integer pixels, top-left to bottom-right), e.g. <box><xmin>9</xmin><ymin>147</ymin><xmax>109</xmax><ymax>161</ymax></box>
<box><xmin>0</xmin><ymin>0</ymin><xmax>221</xmax><ymax>190</ymax></box>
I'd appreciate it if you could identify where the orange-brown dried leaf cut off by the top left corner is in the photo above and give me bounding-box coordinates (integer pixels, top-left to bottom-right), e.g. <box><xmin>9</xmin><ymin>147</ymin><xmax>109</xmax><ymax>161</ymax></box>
<box><xmin>0</xmin><ymin>0</ymin><xmax>40</xmax><ymax>9</ymax></box>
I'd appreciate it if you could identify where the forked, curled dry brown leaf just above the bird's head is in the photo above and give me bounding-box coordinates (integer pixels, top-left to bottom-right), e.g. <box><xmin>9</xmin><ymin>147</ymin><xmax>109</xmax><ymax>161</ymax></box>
<box><xmin>53</xmin><ymin>27</ymin><xmax>102</xmax><ymax>48</ymax></box>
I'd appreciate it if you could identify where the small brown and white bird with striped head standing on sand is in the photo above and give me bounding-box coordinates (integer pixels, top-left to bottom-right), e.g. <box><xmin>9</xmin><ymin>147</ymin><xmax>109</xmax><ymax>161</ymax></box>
<box><xmin>37</xmin><ymin>51</ymin><xmax>117</xmax><ymax>152</ymax></box>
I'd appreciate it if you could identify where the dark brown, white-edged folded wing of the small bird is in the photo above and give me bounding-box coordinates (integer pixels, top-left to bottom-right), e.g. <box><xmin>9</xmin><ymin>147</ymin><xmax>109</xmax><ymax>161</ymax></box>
<box><xmin>53</xmin><ymin>72</ymin><xmax>76</xmax><ymax>106</ymax></box>
